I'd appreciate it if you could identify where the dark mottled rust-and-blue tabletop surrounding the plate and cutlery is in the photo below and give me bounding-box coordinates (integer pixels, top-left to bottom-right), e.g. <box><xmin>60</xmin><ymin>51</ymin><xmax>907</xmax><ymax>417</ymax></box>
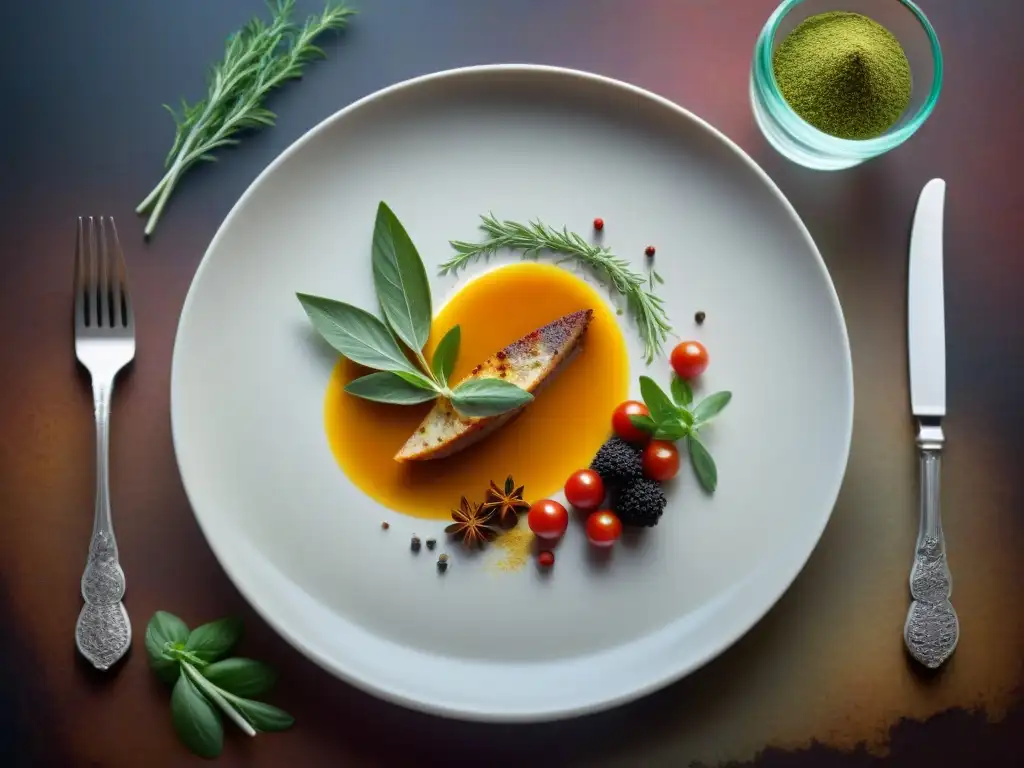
<box><xmin>0</xmin><ymin>0</ymin><xmax>1024</xmax><ymax>768</ymax></box>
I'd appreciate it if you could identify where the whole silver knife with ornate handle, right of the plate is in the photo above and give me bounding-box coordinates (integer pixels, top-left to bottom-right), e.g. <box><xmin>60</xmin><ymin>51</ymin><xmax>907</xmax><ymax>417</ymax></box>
<box><xmin>903</xmin><ymin>179</ymin><xmax>959</xmax><ymax>669</ymax></box>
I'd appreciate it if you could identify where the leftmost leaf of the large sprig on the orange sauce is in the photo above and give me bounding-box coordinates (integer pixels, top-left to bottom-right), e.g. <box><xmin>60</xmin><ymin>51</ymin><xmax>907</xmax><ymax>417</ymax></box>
<box><xmin>297</xmin><ymin>293</ymin><xmax>416</xmax><ymax>373</ymax></box>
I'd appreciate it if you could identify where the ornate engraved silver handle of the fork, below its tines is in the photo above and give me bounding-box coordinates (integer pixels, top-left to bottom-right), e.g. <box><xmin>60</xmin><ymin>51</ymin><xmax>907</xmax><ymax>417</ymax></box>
<box><xmin>75</xmin><ymin>384</ymin><xmax>131</xmax><ymax>670</ymax></box>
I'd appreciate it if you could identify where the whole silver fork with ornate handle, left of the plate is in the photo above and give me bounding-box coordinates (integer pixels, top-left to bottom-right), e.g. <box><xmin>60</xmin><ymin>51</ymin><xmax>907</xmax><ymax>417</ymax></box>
<box><xmin>75</xmin><ymin>216</ymin><xmax>135</xmax><ymax>670</ymax></box>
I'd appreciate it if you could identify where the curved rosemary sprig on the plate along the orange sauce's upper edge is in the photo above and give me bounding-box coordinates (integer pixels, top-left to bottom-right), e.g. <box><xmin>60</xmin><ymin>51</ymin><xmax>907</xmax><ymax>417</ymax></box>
<box><xmin>441</xmin><ymin>214</ymin><xmax>672</xmax><ymax>364</ymax></box>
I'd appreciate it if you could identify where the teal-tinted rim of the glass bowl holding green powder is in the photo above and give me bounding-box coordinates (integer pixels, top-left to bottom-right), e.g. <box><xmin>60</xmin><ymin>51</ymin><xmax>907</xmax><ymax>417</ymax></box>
<box><xmin>755</xmin><ymin>0</ymin><xmax>943</xmax><ymax>157</ymax></box>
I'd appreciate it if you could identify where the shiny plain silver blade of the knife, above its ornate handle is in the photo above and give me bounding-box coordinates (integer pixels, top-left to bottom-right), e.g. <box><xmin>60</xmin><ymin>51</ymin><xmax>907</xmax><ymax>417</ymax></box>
<box><xmin>907</xmin><ymin>178</ymin><xmax>946</xmax><ymax>417</ymax></box>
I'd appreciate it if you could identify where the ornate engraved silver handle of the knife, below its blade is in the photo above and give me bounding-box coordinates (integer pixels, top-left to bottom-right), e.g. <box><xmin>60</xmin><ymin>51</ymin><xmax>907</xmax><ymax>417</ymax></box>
<box><xmin>903</xmin><ymin>422</ymin><xmax>959</xmax><ymax>670</ymax></box>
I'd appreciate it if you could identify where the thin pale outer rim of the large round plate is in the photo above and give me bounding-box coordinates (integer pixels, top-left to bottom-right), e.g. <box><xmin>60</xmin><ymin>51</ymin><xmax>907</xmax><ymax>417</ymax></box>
<box><xmin>170</xmin><ymin>63</ymin><xmax>854</xmax><ymax>723</ymax></box>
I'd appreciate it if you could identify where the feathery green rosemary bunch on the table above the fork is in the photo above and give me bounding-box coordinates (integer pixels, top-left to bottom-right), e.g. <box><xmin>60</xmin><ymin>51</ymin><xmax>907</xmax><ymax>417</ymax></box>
<box><xmin>135</xmin><ymin>0</ymin><xmax>355</xmax><ymax>237</ymax></box>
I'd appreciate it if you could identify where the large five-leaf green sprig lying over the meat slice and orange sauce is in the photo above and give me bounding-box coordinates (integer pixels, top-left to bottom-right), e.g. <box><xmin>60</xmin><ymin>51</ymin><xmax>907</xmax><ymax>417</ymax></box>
<box><xmin>298</xmin><ymin>202</ymin><xmax>534</xmax><ymax>418</ymax></box>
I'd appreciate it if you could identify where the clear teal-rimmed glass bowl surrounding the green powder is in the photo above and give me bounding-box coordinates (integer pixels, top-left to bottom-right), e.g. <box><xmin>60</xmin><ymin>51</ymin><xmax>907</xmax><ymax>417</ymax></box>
<box><xmin>751</xmin><ymin>0</ymin><xmax>942</xmax><ymax>171</ymax></box>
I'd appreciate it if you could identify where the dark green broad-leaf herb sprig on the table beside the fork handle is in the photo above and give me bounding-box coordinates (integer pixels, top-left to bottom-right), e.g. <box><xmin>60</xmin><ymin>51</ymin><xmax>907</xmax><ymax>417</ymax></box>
<box><xmin>145</xmin><ymin>610</ymin><xmax>295</xmax><ymax>758</ymax></box>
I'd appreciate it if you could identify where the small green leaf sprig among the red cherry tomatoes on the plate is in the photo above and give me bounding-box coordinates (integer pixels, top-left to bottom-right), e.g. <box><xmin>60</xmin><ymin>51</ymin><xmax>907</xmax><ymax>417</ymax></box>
<box><xmin>630</xmin><ymin>376</ymin><xmax>732</xmax><ymax>493</ymax></box>
